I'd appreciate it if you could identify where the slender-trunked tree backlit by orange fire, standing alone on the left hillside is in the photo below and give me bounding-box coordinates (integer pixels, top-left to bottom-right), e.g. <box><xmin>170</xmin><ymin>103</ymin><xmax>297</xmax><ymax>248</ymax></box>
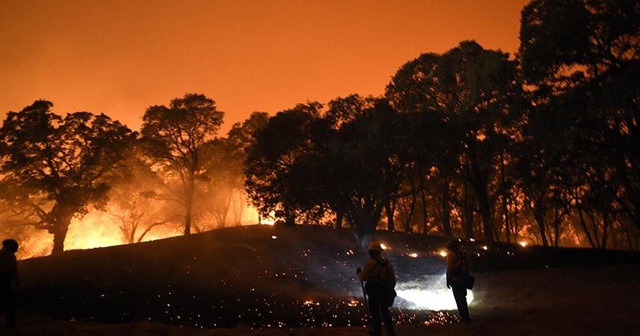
<box><xmin>142</xmin><ymin>94</ymin><xmax>224</xmax><ymax>235</ymax></box>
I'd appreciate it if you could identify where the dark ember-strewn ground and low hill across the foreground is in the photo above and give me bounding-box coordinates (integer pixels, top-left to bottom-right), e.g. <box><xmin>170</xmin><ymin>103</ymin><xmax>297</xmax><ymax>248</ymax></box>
<box><xmin>6</xmin><ymin>226</ymin><xmax>640</xmax><ymax>336</ymax></box>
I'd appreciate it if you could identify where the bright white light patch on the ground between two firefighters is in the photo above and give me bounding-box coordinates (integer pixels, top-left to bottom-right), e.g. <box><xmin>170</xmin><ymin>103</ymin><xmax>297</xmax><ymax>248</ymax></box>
<box><xmin>396</xmin><ymin>274</ymin><xmax>473</xmax><ymax>311</ymax></box>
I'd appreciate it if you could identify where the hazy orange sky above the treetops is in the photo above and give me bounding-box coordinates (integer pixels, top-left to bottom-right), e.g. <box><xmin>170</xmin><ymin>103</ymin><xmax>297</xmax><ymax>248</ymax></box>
<box><xmin>0</xmin><ymin>0</ymin><xmax>529</xmax><ymax>135</ymax></box>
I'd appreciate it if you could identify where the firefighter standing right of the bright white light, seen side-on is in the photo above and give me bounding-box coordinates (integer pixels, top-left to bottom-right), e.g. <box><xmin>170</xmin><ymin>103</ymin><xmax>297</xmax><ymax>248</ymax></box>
<box><xmin>446</xmin><ymin>239</ymin><xmax>471</xmax><ymax>323</ymax></box>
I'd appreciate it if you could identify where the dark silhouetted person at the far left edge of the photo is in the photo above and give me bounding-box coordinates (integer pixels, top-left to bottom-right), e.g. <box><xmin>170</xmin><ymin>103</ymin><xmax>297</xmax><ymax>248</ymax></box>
<box><xmin>0</xmin><ymin>239</ymin><xmax>20</xmax><ymax>328</ymax></box>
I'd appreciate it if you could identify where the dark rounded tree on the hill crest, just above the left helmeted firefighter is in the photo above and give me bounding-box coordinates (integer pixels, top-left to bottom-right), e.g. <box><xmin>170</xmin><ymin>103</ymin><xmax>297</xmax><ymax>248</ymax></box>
<box><xmin>325</xmin><ymin>95</ymin><xmax>407</xmax><ymax>246</ymax></box>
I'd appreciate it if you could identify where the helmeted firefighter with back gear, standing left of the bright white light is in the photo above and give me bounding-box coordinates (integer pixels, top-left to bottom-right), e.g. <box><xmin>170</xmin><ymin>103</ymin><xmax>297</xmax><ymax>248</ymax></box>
<box><xmin>356</xmin><ymin>242</ymin><xmax>396</xmax><ymax>336</ymax></box>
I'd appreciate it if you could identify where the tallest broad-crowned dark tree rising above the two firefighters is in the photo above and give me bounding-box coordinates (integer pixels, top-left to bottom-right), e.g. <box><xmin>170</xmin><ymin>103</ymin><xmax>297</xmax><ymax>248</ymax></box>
<box><xmin>387</xmin><ymin>41</ymin><xmax>518</xmax><ymax>241</ymax></box>
